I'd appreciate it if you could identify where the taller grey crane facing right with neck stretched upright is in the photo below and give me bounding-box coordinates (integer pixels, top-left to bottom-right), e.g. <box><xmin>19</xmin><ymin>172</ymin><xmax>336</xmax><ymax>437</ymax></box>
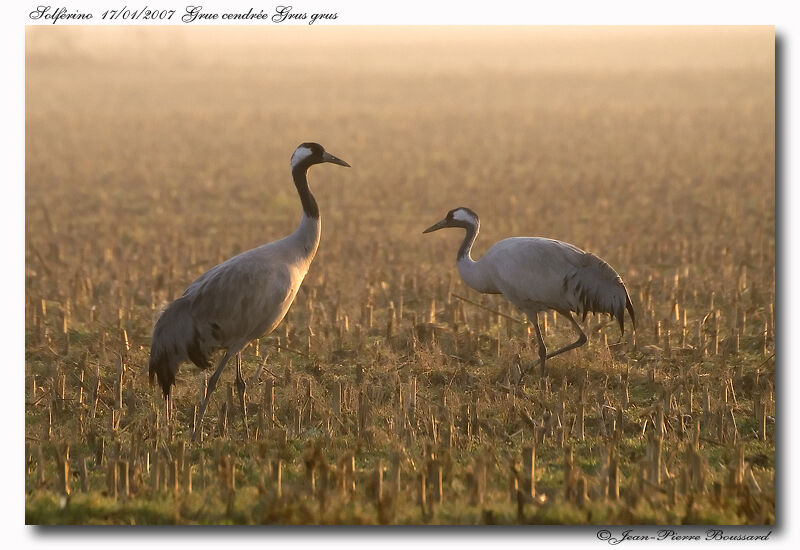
<box><xmin>150</xmin><ymin>143</ymin><xmax>350</xmax><ymax>440</ymax></box>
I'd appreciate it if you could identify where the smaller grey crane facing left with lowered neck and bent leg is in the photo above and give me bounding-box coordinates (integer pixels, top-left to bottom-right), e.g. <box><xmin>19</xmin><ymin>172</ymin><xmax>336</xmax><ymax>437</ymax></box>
<box><xmin>423</xmin><ymin>207</ymin><xmax>636</xmax><ymax>375</ymax></box>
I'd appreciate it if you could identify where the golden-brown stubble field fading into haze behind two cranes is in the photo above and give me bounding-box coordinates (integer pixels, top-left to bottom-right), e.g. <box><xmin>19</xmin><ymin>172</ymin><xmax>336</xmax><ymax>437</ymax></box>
<box><xmin>25</xmin><ymin>27</ymin><xmax>776</xmax><ymax>524</ymax></box>
